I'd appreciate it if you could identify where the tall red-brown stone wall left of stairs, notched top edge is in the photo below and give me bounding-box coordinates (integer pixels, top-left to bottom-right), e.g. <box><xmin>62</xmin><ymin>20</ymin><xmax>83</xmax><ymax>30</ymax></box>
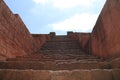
<box><xmin>0</xmin><ymin>0</ymin><xmax>33</xmax><ymax>60</ymax></box>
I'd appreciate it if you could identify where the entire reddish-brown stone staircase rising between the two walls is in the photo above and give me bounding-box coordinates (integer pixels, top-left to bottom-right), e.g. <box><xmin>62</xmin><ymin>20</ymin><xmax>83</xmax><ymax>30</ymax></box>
<box><xmin>0</xmin><ymin>36</ymin><xmax>120</xmax><ymax>80</ymax></box>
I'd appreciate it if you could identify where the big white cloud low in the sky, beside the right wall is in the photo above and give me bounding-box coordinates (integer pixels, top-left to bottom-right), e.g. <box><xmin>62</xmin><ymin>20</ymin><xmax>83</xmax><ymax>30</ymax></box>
<box><xmin>49</xmin><ymin>13</ymin><xmax>98</xmax><ymax>32</ymax></box>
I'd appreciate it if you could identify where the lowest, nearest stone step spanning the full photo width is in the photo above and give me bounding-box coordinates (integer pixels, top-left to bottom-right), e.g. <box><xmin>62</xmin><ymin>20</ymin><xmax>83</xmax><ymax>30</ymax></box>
<box><xmin>0</xmin><ymin>69</ymin><xmax>120</xmax><ymax>80</ymax></box>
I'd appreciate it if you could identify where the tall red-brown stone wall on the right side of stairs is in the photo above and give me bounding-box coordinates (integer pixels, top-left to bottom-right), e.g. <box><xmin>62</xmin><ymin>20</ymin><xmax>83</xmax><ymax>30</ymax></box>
<box><xmin>91</xmin><ymin>0</ymin><xmax>120</xmax><ymax>58</ymax></box>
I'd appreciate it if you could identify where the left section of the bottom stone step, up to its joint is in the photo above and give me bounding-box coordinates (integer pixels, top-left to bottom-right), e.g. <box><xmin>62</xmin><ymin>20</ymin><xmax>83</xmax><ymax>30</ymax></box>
<box><xmin>0</xmin><ymin>69</ymin><xmax>51</xmax><ymax>80</ymax></box>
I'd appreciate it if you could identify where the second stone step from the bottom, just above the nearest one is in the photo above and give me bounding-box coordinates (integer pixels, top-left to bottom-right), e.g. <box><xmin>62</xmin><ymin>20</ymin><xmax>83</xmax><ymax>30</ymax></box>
<box><xmin>0</xmin><ymin>61</ymin><xmax>110</xmax><ymax>70</ymax></box>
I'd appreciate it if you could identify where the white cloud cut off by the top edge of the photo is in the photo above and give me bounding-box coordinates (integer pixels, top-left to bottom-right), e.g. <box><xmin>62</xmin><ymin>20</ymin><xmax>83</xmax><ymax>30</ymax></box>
<box><xmin>33</xmin><ymin>0</ymin><xmax>105</xmax><ymax>9</ymax></box>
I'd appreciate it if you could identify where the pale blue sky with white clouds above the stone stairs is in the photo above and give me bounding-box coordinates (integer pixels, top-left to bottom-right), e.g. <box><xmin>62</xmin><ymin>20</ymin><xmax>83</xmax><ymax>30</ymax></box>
<box><xmin>4</xmin><ymin>0</ymin><xmax>106</xmax><ymax>35</ymax></box>
